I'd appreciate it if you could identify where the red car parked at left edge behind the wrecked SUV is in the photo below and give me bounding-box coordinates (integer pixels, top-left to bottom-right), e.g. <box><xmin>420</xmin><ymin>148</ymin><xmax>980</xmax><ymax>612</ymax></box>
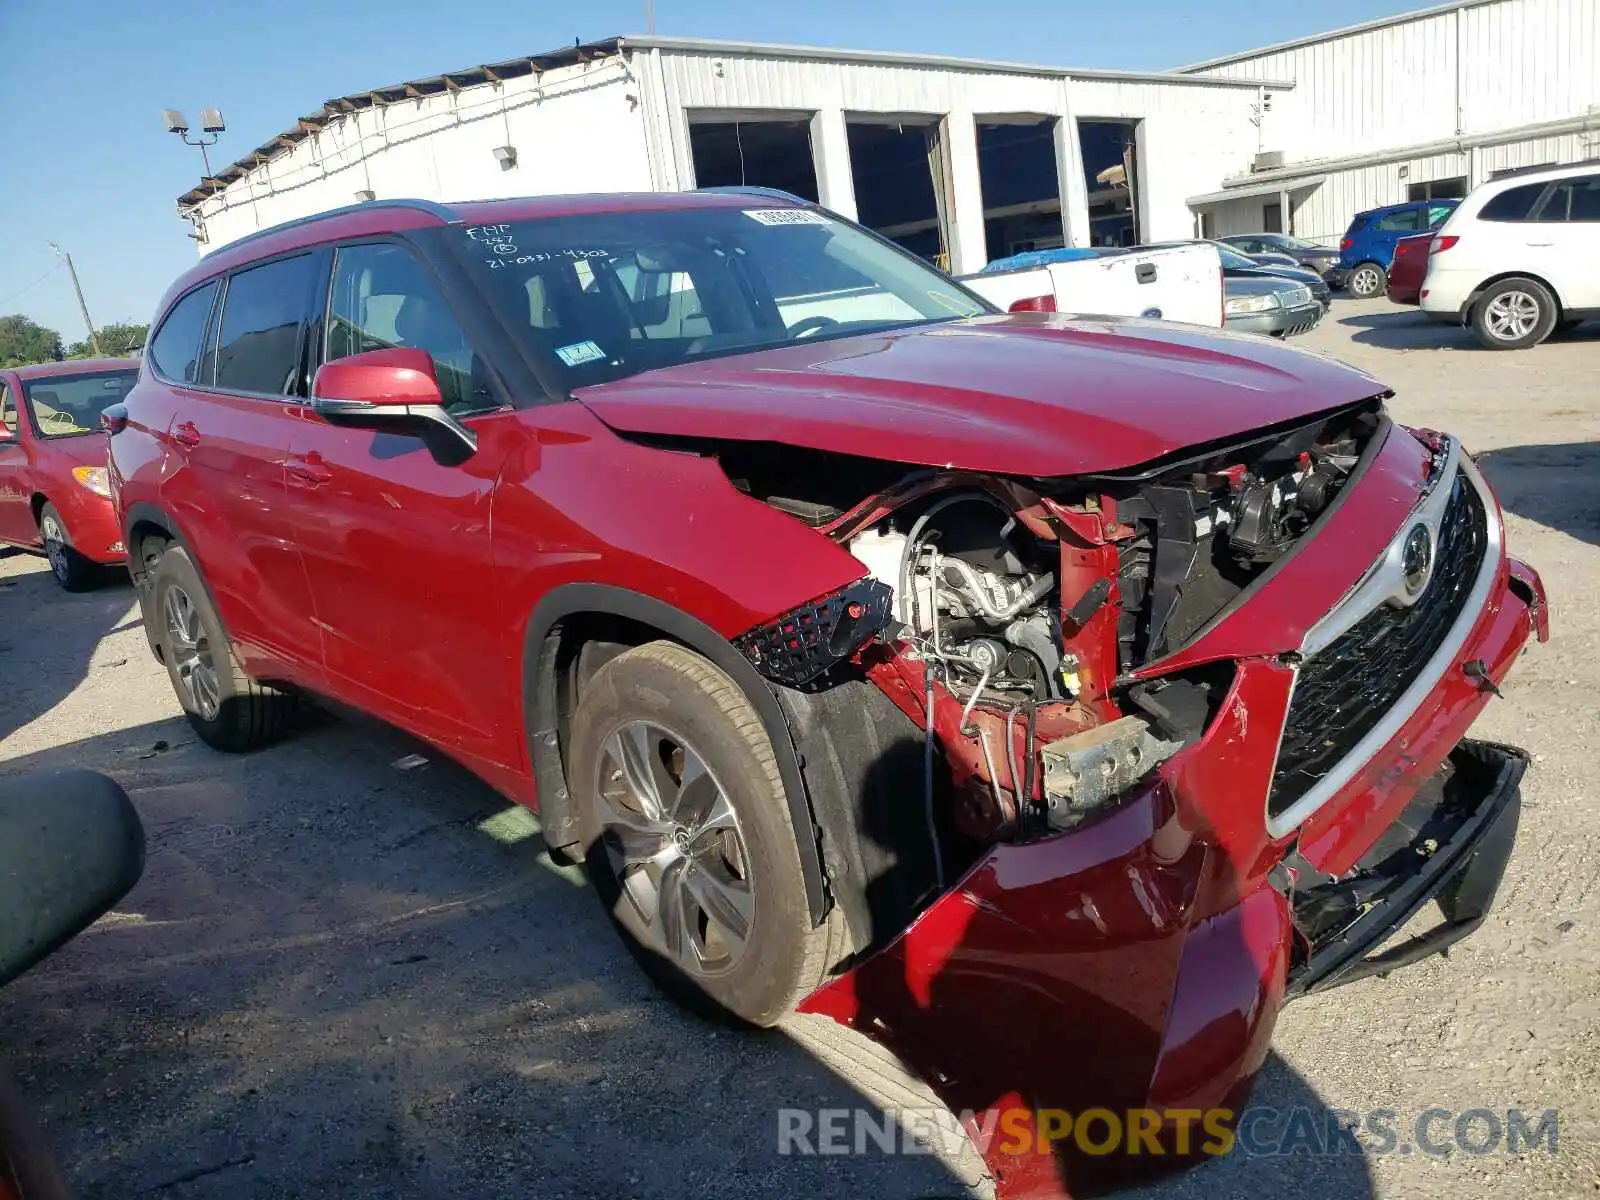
<box><xmin>0</xmin><ymin>358</ymin><xmax>139</xmax><ymax>592</ymax></box>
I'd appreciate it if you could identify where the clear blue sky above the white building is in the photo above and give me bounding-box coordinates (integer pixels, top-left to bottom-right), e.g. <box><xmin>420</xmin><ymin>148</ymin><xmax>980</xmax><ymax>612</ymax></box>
<box><xmin>0</xmin><ymin>0</ymin><xmax>1422</xmax><ymax>342</ymax></box>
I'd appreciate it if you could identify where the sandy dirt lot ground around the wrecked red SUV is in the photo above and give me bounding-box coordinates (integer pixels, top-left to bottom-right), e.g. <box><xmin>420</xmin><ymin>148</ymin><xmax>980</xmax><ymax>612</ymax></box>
<box><xmin>0</xmin><ymin>301</ymin><xmax>1600</xmax><ymax>1200</ymax></box>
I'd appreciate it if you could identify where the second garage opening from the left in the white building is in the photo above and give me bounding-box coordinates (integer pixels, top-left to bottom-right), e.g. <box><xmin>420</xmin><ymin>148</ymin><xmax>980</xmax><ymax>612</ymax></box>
<box><xmin>845</xmin><ymin>118</ymin><xmax>950</xmax><ymax>270</ymax></box>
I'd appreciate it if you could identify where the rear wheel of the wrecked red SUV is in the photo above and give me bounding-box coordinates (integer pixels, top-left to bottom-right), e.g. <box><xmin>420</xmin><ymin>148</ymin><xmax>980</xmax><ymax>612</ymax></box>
<box><xmin>147</xmin><ymin>546</ymin><xmax>294</xmax><ymax>754</ymax></box>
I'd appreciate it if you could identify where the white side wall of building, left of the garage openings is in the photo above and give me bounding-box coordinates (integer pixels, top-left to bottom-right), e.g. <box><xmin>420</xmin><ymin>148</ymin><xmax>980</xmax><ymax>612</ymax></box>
<box><xmin>190</xmin><ymin>59</ymin><xmax>656</xmax><ymax>253</ymax></box>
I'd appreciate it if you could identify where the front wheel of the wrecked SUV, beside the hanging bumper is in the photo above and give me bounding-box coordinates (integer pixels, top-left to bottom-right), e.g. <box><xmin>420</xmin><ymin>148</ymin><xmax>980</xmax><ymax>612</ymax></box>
<box><xmin>568</xmin><ymin>642</ymin><xmax>843</xmax><ymax>1026</ymax></box>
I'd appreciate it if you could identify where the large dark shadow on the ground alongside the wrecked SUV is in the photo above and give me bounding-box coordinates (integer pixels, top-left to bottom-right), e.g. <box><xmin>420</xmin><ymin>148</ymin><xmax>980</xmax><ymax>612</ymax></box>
<box><xmin>0</xmin><ymin>718</ymin><xmax>986</xmax><ymax>1200</ymax></box>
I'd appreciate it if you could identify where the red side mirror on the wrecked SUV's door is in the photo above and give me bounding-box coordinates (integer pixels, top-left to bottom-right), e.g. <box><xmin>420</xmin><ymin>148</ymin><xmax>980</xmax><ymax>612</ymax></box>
<box><xmin>310</xmin><ymin>347</ymin><xmax>478</xmax><ymax>467</ymax></box>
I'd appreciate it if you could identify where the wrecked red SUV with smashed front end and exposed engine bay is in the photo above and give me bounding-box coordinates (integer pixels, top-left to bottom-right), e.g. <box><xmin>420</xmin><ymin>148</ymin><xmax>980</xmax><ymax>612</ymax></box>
<box><xmin>107</xmin><ymin>190</ymin><xmax>1547</xmax><ymax>1195</ymax></box>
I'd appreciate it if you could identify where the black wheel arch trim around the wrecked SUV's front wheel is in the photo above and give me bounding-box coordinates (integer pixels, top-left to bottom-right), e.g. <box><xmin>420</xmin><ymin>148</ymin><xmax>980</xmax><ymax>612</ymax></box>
<box><xmin>522</xmin><ymin>584</ymin><xmax>829</xmax><ymax>925</ymax></box>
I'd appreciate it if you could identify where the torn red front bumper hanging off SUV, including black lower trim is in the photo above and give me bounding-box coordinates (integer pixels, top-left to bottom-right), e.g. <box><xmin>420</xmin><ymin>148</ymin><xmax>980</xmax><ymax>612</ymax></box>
<box><xmin>802</xmin><ymin>560</ymin><xmax>1547</xmax><ymax>1200</ymax></box>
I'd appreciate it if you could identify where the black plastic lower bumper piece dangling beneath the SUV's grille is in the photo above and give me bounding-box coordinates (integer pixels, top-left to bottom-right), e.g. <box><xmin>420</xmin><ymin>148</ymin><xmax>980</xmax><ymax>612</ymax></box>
<box><xmin>1286</xmin><ymin>741</ymin><xmax>1528</xmax><ymax>997</ymax></box>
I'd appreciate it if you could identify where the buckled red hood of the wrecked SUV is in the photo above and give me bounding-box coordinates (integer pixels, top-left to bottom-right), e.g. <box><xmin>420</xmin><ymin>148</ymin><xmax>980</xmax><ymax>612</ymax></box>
<box><xmin>576</xmin><ymin>315</ymin><xmax>1387</xmax><ymax>477</ymax></box>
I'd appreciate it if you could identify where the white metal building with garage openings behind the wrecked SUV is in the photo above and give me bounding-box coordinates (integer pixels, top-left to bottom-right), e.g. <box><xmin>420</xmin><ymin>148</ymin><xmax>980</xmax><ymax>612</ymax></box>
<box><xmin>179</xmin><ymin>0</ymin><xmax>1600</xmax><ymax>274</ymax></box>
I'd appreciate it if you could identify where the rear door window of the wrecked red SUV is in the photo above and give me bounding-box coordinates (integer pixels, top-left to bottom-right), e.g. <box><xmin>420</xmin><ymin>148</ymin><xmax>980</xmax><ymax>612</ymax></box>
<box><xmin>216</xmin><ymin>254</ymin><xmax>318</xmax><ymax>395</ymax></box>
